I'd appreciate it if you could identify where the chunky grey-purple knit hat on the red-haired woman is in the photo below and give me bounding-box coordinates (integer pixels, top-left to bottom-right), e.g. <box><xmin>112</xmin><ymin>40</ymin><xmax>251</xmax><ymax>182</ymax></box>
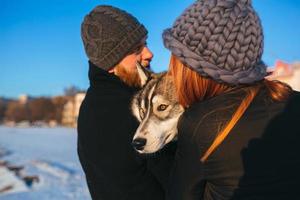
<box><xmin>163</xmin><ymin>0</ymin><xmax>266</xmax><ymax>85</ymax></box>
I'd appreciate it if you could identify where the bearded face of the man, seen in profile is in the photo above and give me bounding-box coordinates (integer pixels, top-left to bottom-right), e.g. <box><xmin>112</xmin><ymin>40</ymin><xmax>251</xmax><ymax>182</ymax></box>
<box><xmin>110</xmin><ymin>39</ymin><xmax>153</xmax><ymax>87</ymax></box>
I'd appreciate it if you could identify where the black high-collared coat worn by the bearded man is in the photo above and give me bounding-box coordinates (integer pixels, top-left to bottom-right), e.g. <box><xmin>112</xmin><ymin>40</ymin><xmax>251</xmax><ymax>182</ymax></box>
<box><xmin>78</xmin><ymin>63</ymin><xmax>175</xmax><ymax>200</ymax></box>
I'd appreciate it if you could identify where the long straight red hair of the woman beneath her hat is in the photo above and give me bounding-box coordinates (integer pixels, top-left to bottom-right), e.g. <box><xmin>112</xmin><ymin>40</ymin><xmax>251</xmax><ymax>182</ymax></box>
<box><xmin>168</xmin><ymin>55</ymin><xmax>291</xmax><ymax>161</ymax></box>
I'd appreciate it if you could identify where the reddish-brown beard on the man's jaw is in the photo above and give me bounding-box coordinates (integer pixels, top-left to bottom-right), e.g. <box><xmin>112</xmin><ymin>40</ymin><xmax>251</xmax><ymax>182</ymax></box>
<box><xmin>114</xmin><ymin>65</ymin><xmax>141</xmax><ymax>87</ymax></box>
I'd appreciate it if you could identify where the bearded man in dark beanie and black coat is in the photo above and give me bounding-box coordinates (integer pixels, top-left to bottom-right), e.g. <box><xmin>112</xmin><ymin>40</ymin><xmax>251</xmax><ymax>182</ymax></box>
<box><xmin>78</xmin><ymin>6</ymin><xmax>173</xmax><ymax>200</ymax></box>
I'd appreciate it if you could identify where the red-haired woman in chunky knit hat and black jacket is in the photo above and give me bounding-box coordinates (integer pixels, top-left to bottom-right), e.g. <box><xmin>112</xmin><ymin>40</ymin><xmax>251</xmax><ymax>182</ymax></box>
<box><xmin>163</xmin><ymin>0</ymin><xmax>300</xmax><ymax>200</ymax></box>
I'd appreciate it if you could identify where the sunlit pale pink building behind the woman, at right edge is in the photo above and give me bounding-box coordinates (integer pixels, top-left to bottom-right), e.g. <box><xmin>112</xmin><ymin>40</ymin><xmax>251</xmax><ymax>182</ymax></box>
<box><xmin>267</xmin><ymin>60</ymin><xmax>300</xmax><ymax>91</ymax></box>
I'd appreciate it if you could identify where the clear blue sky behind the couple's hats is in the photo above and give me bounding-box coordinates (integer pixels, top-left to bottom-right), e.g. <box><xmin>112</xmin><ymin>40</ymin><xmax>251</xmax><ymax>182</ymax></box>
<box><xmin>0</xmin><ymin>0</ymin><xmax>300</xmax><ymax>98</ymax></box>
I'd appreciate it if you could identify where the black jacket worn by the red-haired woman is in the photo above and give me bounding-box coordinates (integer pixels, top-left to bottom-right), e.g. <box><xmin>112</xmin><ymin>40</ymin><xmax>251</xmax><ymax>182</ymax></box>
<box><xmin>168</xmin><ymin>88</ymin><xmax>300</xmax><ymax>200</ymax></box>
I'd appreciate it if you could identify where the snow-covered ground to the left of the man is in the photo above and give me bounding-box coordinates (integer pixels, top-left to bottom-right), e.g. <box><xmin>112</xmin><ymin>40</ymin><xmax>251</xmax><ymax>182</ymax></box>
<box><xmin>0</xmin><ymin>126</ymin><xmax>91</xmax><ymax>200</ymax></box>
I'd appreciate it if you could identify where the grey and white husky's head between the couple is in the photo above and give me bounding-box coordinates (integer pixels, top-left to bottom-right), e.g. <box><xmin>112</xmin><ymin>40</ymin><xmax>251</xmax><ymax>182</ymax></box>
<box><xmin>131</xmin><ymin>64</ymin><xmax>184</xmax><ymax>154</ymax></box>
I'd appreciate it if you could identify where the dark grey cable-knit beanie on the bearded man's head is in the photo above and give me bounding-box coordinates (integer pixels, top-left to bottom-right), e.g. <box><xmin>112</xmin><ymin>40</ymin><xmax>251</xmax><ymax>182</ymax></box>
<box><xmin>81</xmin><ymin>5</ymin><xmax>148</xmax><ymax>70</ymax></box>
